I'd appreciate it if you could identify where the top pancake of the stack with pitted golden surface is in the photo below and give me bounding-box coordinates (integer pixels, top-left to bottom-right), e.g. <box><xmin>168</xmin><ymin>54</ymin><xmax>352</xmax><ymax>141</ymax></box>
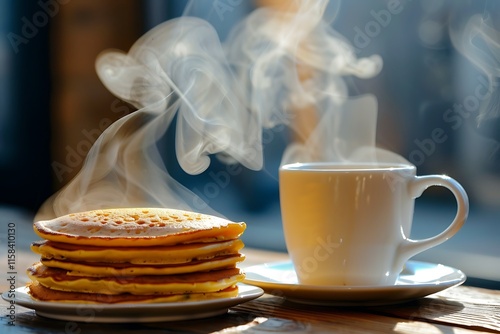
<box><xmin>34</xmin><ymin>208</ymin><xmax>246</xmax><ymax>247</ymax></box>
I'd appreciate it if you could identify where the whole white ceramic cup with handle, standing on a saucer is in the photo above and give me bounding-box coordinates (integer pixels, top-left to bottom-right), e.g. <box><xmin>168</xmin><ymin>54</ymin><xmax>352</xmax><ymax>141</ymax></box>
<box><xmin>279</xmin><ymin>163</ymin><xmax>469</xmax><ymax>286</ymax></box>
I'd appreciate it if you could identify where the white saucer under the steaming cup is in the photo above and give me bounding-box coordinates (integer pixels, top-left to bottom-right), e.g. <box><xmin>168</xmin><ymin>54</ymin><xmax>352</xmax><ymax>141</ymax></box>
<box><xmin>244</xmin><ymin>261</ymin><xmax>466</xmax><ymax>306</ymax></box>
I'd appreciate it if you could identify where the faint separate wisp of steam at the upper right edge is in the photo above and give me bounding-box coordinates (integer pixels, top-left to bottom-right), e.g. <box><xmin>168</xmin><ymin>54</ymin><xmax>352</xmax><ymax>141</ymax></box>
<box><xmin>450</xmin><ymin>13</ymin><xmax>500</xmax><ymax>125</ymax></box>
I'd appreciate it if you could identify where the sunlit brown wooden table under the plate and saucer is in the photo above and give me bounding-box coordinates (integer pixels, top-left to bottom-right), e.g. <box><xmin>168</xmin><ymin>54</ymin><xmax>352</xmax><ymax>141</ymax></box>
<box><xmin>0</xmin><ymin>249</ymin><xmax>500</xmax><ymax>334</ymax></box>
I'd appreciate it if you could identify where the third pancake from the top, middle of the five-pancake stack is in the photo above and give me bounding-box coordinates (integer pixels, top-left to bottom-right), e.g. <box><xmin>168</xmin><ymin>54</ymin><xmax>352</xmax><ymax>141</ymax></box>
<box><xmin>41</xmin><ymin>254</ymin><xmax>245</xmax><ymax>277</ymax></box>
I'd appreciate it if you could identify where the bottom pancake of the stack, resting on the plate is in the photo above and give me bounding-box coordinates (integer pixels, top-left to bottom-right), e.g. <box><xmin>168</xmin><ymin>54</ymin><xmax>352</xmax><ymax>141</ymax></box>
<box><xmin>28</xmin><ymin>282</ymin><xmax>238</xmax><ymax>304</ymax></box>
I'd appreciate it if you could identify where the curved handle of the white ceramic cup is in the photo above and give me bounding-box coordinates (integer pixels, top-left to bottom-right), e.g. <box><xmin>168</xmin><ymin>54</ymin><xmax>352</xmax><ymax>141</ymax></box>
<box><xmin>398</xmin><ymin>175</ymin><xmax>469</xmax><ymax>266</ymax></box>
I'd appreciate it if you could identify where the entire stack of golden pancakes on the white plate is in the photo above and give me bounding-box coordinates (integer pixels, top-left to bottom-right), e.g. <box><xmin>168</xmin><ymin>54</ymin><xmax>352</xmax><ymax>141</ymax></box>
<box><xmin>28</xmin><ymin>208</ymin><xmax>246</xmax><ymax>303</ymax></box>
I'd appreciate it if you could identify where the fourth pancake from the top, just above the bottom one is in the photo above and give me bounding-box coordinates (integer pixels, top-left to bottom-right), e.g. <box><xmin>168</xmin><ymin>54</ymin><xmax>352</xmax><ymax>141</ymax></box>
<box><xmin>27</xmin><ymin>262</ymin><xmax>244</xmax><ymax>295</ymax></box>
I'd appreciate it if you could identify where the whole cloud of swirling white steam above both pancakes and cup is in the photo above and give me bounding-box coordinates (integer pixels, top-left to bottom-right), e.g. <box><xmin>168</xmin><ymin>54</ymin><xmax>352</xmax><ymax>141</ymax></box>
<box><xmin>37</xmin><ymin>0</ymin><xmax>394</xmax><ymax>219</ymax></box>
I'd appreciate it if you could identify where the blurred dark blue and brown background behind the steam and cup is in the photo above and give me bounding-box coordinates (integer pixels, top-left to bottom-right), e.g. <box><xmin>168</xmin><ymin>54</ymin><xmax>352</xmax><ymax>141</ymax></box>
<box><xmin>0</xmin><ymin>0</ymin><xmax>500</xmax><ymax>288</ymax></box>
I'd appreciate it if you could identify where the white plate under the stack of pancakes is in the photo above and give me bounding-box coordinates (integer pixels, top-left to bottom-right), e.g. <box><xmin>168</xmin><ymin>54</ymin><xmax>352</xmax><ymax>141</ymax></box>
<box><xmin>2</xmin><ymin>284</ymin><xmax>264</xmax><ymax>323</ymax></box>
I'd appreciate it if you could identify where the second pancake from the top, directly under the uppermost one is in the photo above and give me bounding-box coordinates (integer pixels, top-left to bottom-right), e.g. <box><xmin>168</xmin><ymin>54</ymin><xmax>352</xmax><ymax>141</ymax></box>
<box><xmin>31</xmin><ymin>239</ymin><xmax>244</xmax><ymax>264</ymax></box>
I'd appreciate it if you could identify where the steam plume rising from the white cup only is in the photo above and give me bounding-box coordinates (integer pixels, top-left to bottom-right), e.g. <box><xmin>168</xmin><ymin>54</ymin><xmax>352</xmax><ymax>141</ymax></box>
<box><xmin>227</xmin><ymin>1</ymin><xmax>382</xmax><ymax>163</ymax></box>
